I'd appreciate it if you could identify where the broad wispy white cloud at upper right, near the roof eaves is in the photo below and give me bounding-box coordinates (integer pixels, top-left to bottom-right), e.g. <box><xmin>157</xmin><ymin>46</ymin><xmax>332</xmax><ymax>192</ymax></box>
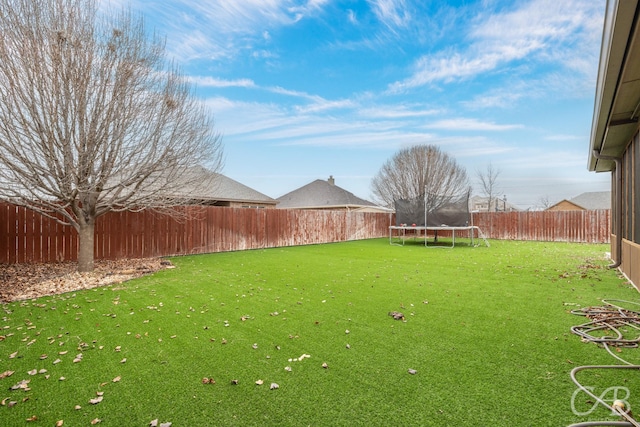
<box><xmin>389</xmin><ymin>0</ymin><xmax>603</xmax><ymax>93</ymax></box>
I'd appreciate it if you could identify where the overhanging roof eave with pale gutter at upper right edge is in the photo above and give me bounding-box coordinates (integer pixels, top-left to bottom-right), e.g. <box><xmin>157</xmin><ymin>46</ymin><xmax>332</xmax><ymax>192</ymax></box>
<box><xmin>587</xmin><ymin>0</ymin><xmax>640</xmax><ymax>172</ymax></box>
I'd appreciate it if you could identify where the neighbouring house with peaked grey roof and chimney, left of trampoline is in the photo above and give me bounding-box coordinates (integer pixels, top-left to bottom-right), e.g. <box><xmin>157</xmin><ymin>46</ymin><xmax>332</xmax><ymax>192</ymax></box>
<box><xmin>278</xmin><ymin>176</ymin><xmax>391</xmax><ymax>212</ymax></box>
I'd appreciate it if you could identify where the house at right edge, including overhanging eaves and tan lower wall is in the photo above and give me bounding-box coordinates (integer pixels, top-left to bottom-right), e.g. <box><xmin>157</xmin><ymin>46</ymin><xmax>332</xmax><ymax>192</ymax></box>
<box><xmin>588</xmin><ymin>0</ymin><xmax>640</xmax><ymax>289</ymax></box>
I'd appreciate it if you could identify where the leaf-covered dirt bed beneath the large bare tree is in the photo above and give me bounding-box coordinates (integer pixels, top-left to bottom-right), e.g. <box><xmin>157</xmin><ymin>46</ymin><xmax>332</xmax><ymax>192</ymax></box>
<box><xmin>0</xmin><ymin>258</ymin><xmax>173</xmax><ymax>304</ymax></box>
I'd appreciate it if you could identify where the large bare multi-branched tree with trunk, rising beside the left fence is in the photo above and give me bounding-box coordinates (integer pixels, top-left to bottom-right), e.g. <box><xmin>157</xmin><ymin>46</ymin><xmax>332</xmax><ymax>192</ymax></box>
<box><xmin>0</xmin><ymin>0</ymin><xmax>222</xmax><ymax>271</ymax></box>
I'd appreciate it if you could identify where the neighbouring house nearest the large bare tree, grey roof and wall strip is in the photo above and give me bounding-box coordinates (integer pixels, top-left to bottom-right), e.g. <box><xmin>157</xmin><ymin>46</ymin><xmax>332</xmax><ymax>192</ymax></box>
<box><xmin>175</xmin><ymin>166</ymin><xmax>278</xmax><ymax>209</ymax></box>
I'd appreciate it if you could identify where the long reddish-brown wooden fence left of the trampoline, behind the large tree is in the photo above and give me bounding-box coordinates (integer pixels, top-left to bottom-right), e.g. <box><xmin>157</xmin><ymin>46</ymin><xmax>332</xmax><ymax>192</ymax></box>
<box><xmin>0</xmin><ymin>204</ymin><xmax>391</xmax><ymax>263</ymax></box>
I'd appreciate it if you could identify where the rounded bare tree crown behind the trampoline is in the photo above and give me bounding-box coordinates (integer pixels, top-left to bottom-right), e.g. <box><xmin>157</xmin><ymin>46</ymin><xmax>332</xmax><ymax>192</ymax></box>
<box><xmin>371</xmin><ymin>145</ymin><xmax>469</xmax><ymax>210</ymax></box>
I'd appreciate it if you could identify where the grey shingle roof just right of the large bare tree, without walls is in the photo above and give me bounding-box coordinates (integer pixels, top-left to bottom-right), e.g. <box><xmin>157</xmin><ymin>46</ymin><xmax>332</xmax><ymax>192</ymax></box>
<box><xmin>175</xmin><ymin>166</ymin><xmax>278</xmax><ymax>205</ymax></box>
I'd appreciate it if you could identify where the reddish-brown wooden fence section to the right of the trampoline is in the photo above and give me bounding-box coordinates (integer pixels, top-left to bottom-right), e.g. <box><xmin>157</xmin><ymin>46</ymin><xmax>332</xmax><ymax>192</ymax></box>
<box><xmin>473</xmin><ymin>209</ymin><xmax>611</xmax><ymax>243</ymax></box>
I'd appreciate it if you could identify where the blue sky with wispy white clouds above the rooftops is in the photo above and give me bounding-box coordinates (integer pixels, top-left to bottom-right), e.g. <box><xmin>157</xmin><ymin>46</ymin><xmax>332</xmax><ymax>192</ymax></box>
<box><xmin>103</xmin><ymin>0</ymin><xmax>610</xmax><ymax>208</ymax></box>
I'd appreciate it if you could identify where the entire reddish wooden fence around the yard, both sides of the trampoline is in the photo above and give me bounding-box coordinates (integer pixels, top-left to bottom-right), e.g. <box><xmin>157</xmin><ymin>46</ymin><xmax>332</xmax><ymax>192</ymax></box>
<box><xmin>0</xmin><ymin>204</ymin><xmax>611</xmax><ymax>264</ymax></box>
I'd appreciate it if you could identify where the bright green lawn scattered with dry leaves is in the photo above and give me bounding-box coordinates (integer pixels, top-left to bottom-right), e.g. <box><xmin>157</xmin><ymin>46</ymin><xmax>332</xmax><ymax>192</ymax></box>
<box><xmin>0</xmin><ymin>239</ymin><xmax>640</xmax><ymax>427</ymax></box>
